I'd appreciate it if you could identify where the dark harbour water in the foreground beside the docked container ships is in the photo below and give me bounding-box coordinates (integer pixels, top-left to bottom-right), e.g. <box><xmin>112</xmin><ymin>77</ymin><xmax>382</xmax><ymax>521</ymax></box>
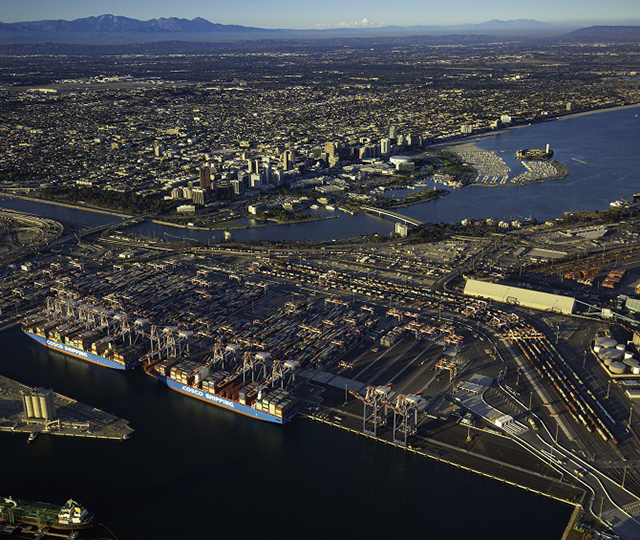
<box><xmin>0</xmin><ymin>330</ymin><xmax>571</xmax><ymax>540</ymax></box>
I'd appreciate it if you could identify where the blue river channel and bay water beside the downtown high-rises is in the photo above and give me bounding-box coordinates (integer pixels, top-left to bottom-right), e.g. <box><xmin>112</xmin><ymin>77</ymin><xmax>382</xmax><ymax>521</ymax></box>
<box><xmin>0</xmin><ymin>107</ymin><xmax>640</xmax><ymax>242</ymax></box>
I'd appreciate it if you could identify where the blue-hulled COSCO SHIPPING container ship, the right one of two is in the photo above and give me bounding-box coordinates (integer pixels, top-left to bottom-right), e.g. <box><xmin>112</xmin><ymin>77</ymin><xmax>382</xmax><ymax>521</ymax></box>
<box><xmin>144</xmin><ymin>359</ymin><xmax>298</xmax><ymax>424</ymax></box>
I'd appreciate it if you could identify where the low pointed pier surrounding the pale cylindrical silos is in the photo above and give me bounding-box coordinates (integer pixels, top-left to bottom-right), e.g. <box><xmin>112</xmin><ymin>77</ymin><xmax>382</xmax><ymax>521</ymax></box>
<box><xmin>0</xmin><ymin>375</ymin><xmax>134</xmax><ymax>440</ymax></box>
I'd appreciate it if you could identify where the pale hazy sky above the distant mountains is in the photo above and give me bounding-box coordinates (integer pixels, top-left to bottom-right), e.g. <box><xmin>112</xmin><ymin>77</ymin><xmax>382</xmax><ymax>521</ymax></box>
<box><xmin>0</xmin><ymin>0</ymin><xmax>640</xmax><ymax>28</ymax></box>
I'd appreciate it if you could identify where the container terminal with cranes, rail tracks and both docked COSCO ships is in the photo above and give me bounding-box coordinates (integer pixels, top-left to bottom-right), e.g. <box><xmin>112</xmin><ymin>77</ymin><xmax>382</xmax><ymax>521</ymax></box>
<box><xmin>6</xmin><ymin>213</ymin><xmax>640</xmax><ymax>539</ymax></box>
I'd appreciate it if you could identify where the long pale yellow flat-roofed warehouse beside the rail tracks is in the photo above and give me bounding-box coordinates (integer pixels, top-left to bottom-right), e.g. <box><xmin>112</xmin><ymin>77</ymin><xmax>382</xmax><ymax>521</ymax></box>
<box><xmin>464</xmin><ymin>279</ymin><xmax>575</xmax><ymax>315</ymax></box>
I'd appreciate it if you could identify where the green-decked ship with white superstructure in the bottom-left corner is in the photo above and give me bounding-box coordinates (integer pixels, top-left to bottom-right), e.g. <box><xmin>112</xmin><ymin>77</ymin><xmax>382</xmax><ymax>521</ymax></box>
<box><xmin>0</xmin><ymin>497</ymin><xmax>94</xmax><ymax>530</ymax></box>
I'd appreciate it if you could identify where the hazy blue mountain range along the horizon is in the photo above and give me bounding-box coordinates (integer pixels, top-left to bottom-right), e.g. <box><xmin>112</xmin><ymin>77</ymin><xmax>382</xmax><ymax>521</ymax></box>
<box><xmin>0</xmin><ymin>14</ymin><xmax>640</xmax><ymax>45</ymax></box>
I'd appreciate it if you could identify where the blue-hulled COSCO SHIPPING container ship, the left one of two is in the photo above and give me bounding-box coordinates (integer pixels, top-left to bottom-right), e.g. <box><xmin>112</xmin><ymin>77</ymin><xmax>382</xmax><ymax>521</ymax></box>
<box><xmin>22</xmin><ymin>308</ymin><xmax>145</xmax><ymax>369</ymax></box>
